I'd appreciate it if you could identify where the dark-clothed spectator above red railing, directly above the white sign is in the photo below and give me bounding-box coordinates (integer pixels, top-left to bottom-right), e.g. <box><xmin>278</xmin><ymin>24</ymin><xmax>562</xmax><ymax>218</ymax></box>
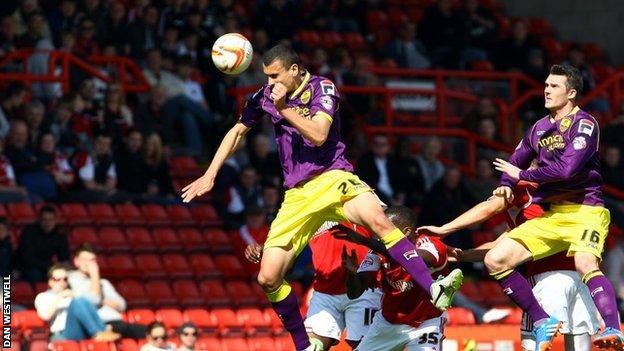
<box><xmin>387</xmin><ymin>22</ymin><xmax>431</xmax><ymax>69</ymax></box>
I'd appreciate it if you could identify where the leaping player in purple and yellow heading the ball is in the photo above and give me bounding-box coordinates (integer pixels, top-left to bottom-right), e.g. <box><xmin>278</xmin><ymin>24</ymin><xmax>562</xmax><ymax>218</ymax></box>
<box><xmin>182</xmin><ymin>45</ymin><xmax>463</xmax><ymax>350</ymax></box>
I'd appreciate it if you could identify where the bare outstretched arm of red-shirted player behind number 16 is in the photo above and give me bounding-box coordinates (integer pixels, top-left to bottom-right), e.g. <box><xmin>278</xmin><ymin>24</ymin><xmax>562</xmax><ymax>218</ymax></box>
<box><xmin>418</xmin><ymin>196</ymin><xmax>508</xmax><ymax>237</ymax></box>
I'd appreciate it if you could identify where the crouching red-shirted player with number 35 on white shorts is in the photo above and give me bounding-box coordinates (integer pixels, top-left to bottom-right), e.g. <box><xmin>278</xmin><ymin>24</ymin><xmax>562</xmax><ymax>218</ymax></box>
<box><xmin>343</xmin><ymin>206</ymin><xmax>447</xmax><ymax>351</ymax></box>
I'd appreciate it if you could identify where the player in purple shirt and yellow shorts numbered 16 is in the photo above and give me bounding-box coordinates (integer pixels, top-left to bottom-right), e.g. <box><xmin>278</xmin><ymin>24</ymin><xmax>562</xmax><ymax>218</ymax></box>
<box><xmin>484</xmin><ymin>65</ymin><xmax>624</xmax><ymax>351</ymax></box>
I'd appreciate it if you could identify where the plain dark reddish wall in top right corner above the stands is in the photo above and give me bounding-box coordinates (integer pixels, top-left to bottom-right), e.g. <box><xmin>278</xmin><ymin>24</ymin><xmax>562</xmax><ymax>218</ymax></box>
<box><xmin>503</xmin><ymin>0</ymin><xmax>624</xmax><ymax>65</ymax></box>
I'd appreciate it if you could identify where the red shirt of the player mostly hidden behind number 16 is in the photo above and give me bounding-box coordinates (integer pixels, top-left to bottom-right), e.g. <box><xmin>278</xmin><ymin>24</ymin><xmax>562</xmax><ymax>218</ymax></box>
<box><xmin>508</xmin><ymin>180</ymin><xmax>576</xmax><ymax>277</ymax></box>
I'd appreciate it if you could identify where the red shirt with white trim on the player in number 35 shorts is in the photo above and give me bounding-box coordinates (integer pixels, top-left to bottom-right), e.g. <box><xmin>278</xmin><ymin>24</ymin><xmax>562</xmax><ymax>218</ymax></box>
<box><xmin>358</xmin><ymin>235</ymin><xmax>448</xmax><ymax>327</ymax></box>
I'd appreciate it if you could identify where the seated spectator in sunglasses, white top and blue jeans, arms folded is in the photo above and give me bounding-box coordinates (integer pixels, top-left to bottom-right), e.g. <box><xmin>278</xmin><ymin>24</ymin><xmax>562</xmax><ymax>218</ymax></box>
<box><xmin>35</xmin><ymin>265</ymin><xmax>120</xmax><ymax>342</ymax></box>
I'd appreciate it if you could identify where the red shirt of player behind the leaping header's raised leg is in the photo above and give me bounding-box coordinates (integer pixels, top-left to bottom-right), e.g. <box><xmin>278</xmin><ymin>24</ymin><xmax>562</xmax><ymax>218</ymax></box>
<box><xmin>309</xmin><ymin>222</ymin><xmax>371</xmax><ymax>295</ymax></box>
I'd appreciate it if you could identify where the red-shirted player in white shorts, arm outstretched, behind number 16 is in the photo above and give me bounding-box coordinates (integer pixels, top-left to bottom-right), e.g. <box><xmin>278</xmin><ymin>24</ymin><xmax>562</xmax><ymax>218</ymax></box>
<box><xmin>418</xmin><ymin>181</ymin><xmax>600</xmax><ymax>351</ymax></box>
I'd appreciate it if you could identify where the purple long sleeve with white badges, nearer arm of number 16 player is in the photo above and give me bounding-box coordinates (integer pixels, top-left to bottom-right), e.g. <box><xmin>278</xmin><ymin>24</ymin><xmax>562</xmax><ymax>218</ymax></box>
<box><xmin>520</xmin><ymin>118</ymin><xmax>600</xmax><ymax>184</ymax></box>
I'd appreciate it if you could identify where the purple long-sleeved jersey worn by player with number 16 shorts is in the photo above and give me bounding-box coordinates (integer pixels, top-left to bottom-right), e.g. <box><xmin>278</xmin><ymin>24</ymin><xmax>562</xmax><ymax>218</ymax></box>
<box><xmin>501</xmin><ymin>107</ymin><xmax>604</xmax><ymax>205</ymax></box>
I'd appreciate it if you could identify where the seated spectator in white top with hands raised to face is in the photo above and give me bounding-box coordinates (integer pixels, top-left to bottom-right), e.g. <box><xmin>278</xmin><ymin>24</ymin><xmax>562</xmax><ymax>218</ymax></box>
<box><xmin>69</xmin><ymin>244</ymin><xmax>146</xmax><ymax>339</ymax></box>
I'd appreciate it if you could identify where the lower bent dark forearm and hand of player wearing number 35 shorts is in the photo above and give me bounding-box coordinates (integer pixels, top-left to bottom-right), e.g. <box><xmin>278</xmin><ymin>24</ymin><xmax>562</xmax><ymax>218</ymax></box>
<box><xmin>342</xmin><ymin>246</ymin><xmax>381</xmax><ymax>300</ymax></box>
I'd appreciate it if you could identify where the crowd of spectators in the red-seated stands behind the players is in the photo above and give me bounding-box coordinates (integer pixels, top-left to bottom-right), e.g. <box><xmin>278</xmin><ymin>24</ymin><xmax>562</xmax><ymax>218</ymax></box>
<box><xmin>0</xmin><ymin>0</ymin><xmax>624</xmax><ymax>350</ymax></box>
